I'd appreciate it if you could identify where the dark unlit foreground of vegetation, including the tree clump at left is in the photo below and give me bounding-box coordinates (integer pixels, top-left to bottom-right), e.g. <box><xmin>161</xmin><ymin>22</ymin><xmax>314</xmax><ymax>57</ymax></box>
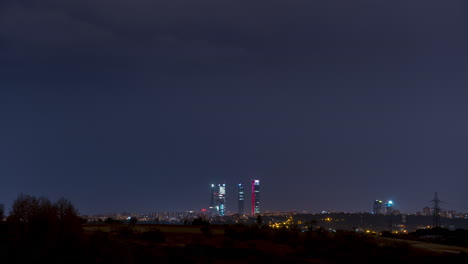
<box><xmin>0</xmin><ymin>195</ymin><xmax>468</xmax><ymax>264</ymax></box>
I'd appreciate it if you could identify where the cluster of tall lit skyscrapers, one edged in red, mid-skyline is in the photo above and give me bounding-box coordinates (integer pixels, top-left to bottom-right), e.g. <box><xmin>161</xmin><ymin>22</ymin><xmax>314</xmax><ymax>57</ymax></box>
<box><xmin>209</xmin><ymin>180</ymin><xmax>260</xmax><ymax>216</ymax></box>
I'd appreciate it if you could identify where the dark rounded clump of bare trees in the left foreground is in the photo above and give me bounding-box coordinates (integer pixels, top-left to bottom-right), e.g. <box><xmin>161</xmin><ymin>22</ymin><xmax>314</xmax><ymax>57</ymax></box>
<box><xmin>0</xmin><ymin>195</ymin><xmax>83</xmax><ymax>263</ymax></box>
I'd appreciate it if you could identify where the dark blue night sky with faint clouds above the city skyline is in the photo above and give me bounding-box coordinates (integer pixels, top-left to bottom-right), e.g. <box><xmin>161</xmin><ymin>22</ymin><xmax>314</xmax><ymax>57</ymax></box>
<box><xmin>0</xmin><ymin>0</ymin><xmax>468</xmax><ymax>213</ymax></box>
